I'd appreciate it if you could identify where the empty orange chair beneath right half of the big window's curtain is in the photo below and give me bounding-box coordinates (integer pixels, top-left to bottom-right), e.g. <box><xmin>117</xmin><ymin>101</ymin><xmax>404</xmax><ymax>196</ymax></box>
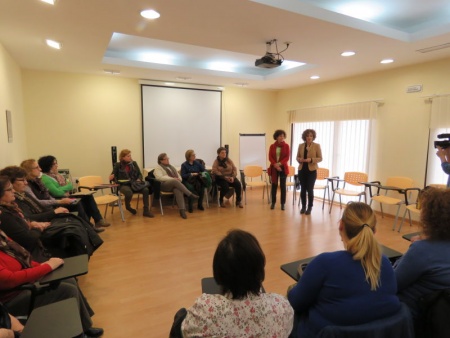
<box><xmin>329</xmin><ymin>171</ymin><xmax>368</xmax><ymax>213</ymax></box>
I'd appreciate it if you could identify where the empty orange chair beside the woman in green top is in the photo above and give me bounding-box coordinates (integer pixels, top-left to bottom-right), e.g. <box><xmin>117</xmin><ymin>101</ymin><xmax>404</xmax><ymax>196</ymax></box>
<box><xmin>78</xmin><ymin>176</ymin><xmax>125</xmax><ymax>221</ymax></box>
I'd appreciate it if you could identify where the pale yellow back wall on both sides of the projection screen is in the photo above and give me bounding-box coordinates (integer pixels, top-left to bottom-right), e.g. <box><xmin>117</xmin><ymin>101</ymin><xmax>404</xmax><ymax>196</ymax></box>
<box><xmin>23</xmin><ymin>70</ymin><xmax>276</xmax><ymax>179</ymax></box>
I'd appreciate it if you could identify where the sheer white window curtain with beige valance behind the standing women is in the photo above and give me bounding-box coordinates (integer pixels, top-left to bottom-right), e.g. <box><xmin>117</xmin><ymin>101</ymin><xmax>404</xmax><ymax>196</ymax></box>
<box><xmin>289</xmin><ymin>102</ymin><xmax>378</xmax><ymax>202</ymax></box>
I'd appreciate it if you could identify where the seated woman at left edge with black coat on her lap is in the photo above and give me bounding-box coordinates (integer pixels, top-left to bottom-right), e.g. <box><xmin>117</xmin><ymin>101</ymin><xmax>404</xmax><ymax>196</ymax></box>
<box><xmin>0</xmin><ymin>166</ymin><xmax>103</xmax><ymax>258</ymax></box>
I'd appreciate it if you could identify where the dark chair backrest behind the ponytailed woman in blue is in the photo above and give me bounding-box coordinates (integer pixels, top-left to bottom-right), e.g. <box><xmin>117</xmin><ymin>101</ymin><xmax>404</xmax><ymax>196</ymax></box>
<box><xmin>316</xmin><ymin>304</ymin><xmax>414</xmax><ymax>338</ymax></box>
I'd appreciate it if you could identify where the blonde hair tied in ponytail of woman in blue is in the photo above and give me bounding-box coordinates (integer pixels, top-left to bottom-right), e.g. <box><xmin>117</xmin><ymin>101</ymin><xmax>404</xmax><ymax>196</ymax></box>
<box><xmin>342</xmin><ymin>202</ymin><xmax>382</xmax><ymax>290</ymax></box>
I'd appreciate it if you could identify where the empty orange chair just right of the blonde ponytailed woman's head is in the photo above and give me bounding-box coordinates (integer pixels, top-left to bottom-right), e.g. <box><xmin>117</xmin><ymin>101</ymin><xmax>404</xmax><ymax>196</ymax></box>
<box><xmin>369</xmin><ymin>176</ymin><xmax>414</xmax><ymax>230</ymax></box>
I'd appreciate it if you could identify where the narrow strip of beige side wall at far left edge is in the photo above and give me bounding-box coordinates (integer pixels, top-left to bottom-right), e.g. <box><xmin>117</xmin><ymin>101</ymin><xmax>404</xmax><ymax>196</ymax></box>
<box><xmin>0</xmin><ymin>44</ymin><xmax>27</xmax><ymax>168</ymax></box>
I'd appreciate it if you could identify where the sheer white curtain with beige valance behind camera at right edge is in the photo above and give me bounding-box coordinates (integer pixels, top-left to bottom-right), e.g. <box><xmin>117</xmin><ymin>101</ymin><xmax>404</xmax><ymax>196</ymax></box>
<box><xmin>426</xmin><ymin>95</ymin><xmax>450</xmax><ymax>185</ymax></box>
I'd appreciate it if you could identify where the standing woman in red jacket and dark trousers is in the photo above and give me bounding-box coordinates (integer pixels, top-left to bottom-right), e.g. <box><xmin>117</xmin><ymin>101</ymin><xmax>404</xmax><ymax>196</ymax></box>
<box><xmin>268</xmin><ymin>129</ymin><xmax>290</xmax><ymax>210</ymax></box>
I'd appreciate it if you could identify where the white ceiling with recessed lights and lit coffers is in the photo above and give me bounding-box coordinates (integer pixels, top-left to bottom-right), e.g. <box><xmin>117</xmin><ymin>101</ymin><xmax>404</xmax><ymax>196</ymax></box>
<box><xmin>0</xmin><ymin>0</ymin><xmax>450</xmax><ymax>89</ymax></box>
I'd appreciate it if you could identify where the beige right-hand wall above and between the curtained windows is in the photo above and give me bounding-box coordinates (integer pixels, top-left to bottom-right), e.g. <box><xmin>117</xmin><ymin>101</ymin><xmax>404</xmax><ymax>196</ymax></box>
<box><xmin>277</xmin><ymin>59</ymin><xmax>450</xmax><ymax>186</ymax></box>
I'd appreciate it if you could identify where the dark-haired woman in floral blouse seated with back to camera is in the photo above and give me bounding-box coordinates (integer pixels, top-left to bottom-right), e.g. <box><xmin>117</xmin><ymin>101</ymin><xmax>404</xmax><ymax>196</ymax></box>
<box><xmin>181</xmin><ymin>230</ymin><xmax>294</xmax><ymax>338</ymax></box>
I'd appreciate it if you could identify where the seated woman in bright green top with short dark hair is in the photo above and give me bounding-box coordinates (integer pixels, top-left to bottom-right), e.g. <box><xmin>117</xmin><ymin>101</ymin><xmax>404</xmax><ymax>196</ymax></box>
<box><xmin>38</xmin><ymin>155</ymin><xmax>111</xmax><ymax>228</ymax></box>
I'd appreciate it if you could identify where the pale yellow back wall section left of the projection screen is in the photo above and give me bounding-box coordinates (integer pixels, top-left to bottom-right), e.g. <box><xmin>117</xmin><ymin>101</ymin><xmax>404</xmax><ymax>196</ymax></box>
<box><xmin>23</xmin><ymin>70</ymin><xmax>142</xmax><ymax>180</ymax></box>
